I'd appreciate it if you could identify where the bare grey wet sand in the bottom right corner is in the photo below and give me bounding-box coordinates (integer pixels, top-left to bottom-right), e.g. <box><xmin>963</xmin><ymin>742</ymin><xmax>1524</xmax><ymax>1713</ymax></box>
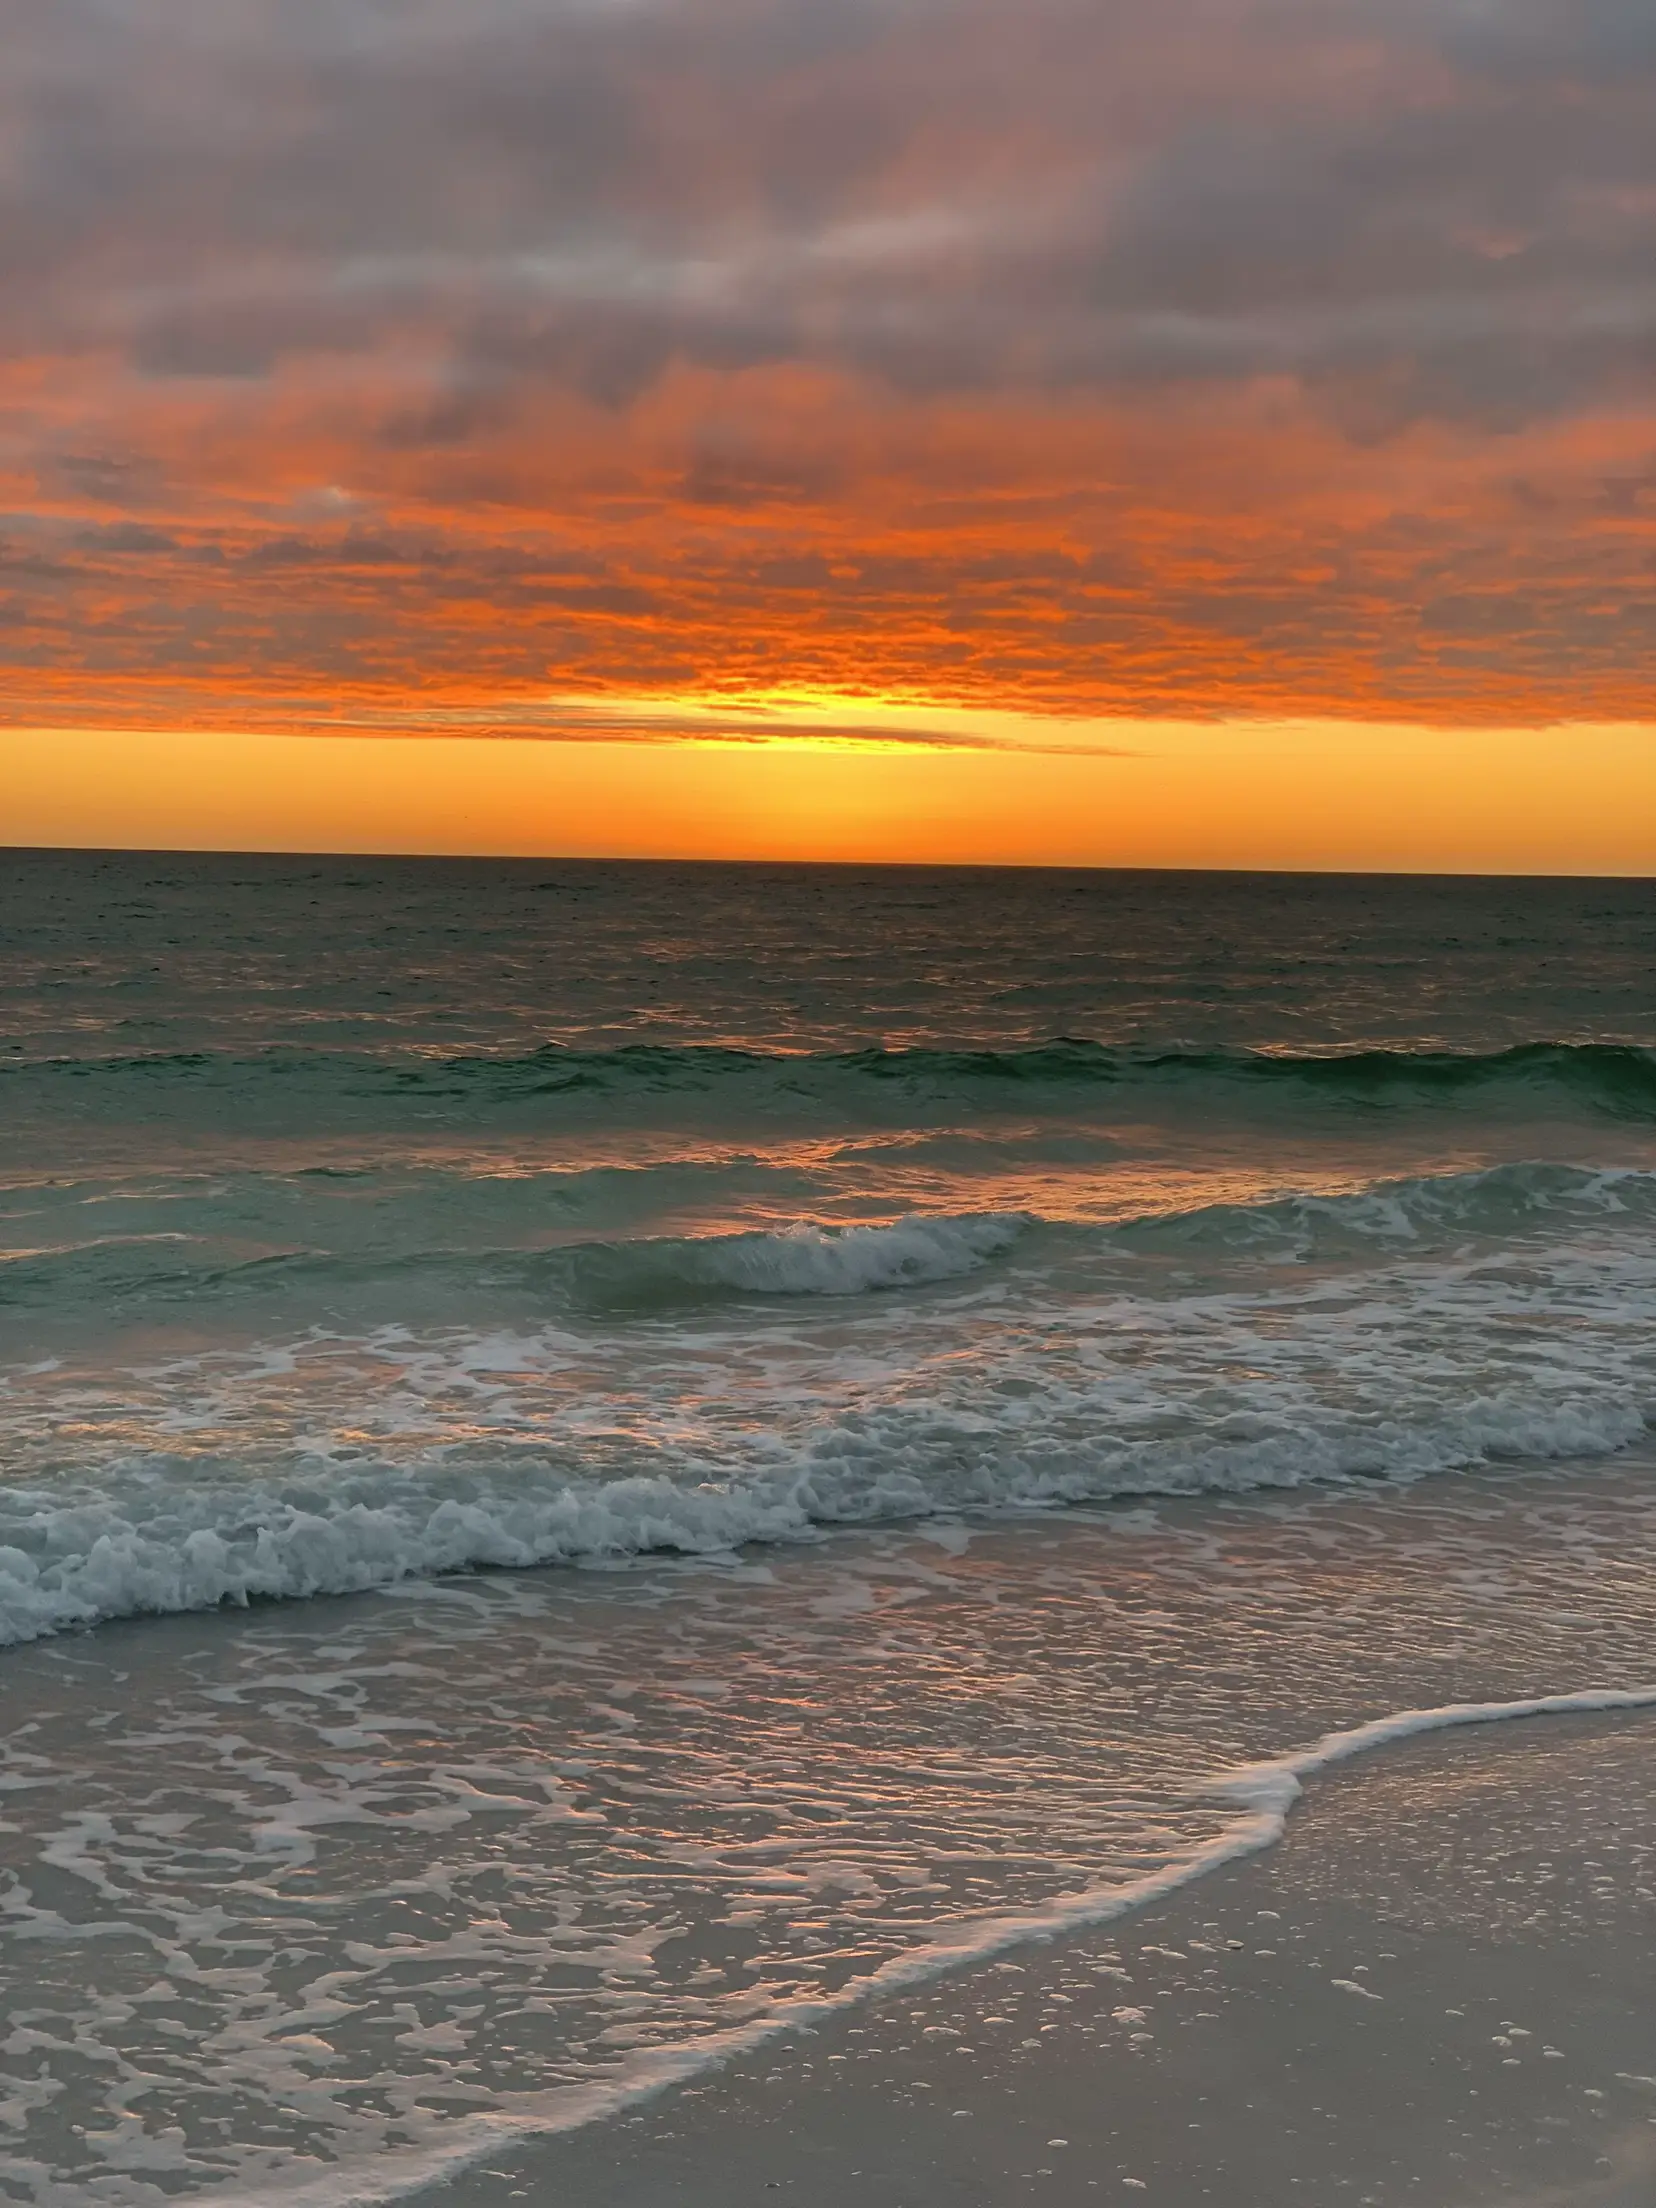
<box><xmin>426</xmin><ymin>1718</ymin><xmax>1656</xmax><ymax>2208</ymax></box>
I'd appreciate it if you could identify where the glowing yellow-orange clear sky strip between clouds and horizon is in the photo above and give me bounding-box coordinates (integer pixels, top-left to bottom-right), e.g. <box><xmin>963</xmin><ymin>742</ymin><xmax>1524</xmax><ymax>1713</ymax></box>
<box><xmin>0</xmin><ymin>710</ymin><xmax>1656</xmax><ymax>874</ymax></box>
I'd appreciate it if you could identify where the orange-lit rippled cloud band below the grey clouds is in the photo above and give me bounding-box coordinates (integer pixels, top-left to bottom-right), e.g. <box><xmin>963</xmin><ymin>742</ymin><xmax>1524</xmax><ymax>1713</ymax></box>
<box><xmin>0</xmin><ymin>371</ymin><xmax>1656</xmax><ymax>733</ymax></box>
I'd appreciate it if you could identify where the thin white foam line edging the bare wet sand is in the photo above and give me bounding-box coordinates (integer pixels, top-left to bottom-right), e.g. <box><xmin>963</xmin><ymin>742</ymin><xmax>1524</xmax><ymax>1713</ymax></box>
<box><xmin>227</xmin><ymin>1685</ymin><xmax>1656</xmax><ymax>2208</ymax></box>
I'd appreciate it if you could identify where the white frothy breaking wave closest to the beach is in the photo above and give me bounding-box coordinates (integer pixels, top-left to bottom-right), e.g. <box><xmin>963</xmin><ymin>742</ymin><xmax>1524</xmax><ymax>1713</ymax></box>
<box><xmin>0</xmin><ymin>1387</ymin><xmax>1656</xmax><ymax>1645</ymax></box>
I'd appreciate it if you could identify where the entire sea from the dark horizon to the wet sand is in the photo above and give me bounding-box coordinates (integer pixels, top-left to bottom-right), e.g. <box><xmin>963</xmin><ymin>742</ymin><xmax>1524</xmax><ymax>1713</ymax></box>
<box><xmin>0</xmin><ymin>852</ymin><xmax>1656</xmax><ymax>2208</ymax></box>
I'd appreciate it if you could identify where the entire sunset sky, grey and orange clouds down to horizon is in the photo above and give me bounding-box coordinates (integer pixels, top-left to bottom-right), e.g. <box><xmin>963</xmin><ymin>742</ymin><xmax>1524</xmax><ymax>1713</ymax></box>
<box><xmin>0</xmin><ymin>0</ymin><xmax>1656</xmax><ymax>872</ymax></box>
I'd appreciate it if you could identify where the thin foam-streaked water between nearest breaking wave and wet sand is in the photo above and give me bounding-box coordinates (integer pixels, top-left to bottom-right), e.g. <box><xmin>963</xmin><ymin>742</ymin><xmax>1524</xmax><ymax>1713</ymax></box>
<box><xmin>0</xmin><ymin>1462</ymin><xmax>1656</xmax><ymax>2208</ymax></box>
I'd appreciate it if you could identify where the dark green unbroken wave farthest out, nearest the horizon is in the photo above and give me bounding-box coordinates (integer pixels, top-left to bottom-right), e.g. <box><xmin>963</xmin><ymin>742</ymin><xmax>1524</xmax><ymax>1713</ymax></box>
<box><xmin>0</xmin><ymin>1038</ymin><xmax>1656</xmax><ymax>1124</ymax></box>
